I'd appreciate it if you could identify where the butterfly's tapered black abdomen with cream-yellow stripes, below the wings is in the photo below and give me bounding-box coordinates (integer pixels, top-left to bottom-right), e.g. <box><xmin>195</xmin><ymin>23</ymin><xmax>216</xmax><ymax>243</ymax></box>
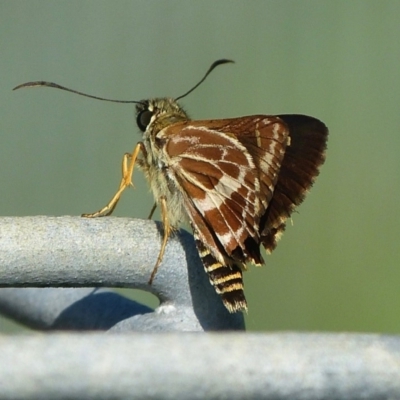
<box><xmin>194</xmin><ymin>232</ymin><xmax>247</xmax><ymax>313</ymax></box>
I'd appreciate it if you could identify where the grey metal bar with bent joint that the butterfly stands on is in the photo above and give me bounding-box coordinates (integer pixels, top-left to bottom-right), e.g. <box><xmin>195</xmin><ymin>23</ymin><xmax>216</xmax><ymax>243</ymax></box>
<box><xmin>0</xmin><ymin>217</ymin><xmax>244</xmax><ymax>331</ymax></box>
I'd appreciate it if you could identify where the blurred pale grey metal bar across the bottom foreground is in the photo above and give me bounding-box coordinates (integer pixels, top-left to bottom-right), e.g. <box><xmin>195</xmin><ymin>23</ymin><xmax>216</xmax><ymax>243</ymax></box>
<box><xmin>0</xmin><ymin>333</ymin><xmax>400</xmax><ymax>400</ymax></box>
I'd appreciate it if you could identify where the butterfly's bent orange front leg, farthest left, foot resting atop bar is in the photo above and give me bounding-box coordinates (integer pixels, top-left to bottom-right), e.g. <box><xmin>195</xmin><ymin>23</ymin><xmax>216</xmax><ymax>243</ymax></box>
<box><xmin>82</xmin><ymin>142</ymin><xmax>144</xmax><ymax>218</ymax></box>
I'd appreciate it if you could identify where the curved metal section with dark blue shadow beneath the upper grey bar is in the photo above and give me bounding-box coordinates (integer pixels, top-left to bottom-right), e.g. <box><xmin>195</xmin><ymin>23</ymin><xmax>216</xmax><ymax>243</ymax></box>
<box><xmin>0</xmin><ymin>288</ymin><xmax>154</xmax><ymax>331</ymax></box>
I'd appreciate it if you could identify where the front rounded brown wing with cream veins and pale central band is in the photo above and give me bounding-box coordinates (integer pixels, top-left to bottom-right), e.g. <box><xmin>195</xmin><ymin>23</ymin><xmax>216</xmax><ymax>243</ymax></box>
<box><xmin>165</xmin><ymin>121</ymin><xmax>264</xmax><ymax>262</ymax></box>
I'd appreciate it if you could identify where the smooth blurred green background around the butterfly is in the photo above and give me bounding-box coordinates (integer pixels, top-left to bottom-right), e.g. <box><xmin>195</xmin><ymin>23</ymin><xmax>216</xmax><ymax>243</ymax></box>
<box><xmin>0</xmin><ymin>0</ymin><xmax>400</xmax><ymax>333</ymax></box>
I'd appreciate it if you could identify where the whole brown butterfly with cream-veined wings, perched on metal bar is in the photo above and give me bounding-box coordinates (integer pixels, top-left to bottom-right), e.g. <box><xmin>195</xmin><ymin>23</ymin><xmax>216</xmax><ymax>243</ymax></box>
<box><xmin>15</xmin><ymin>59</ymin><xmax>328</xmax><ymax>313</ymax></box>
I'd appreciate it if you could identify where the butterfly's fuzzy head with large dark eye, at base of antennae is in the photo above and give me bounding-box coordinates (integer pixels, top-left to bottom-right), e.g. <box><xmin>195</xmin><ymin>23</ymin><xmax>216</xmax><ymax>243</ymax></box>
<box><xmin>136</xmin><ymin>97</ymin><xmax>189</xmax><ymax>132</ymax></box>
